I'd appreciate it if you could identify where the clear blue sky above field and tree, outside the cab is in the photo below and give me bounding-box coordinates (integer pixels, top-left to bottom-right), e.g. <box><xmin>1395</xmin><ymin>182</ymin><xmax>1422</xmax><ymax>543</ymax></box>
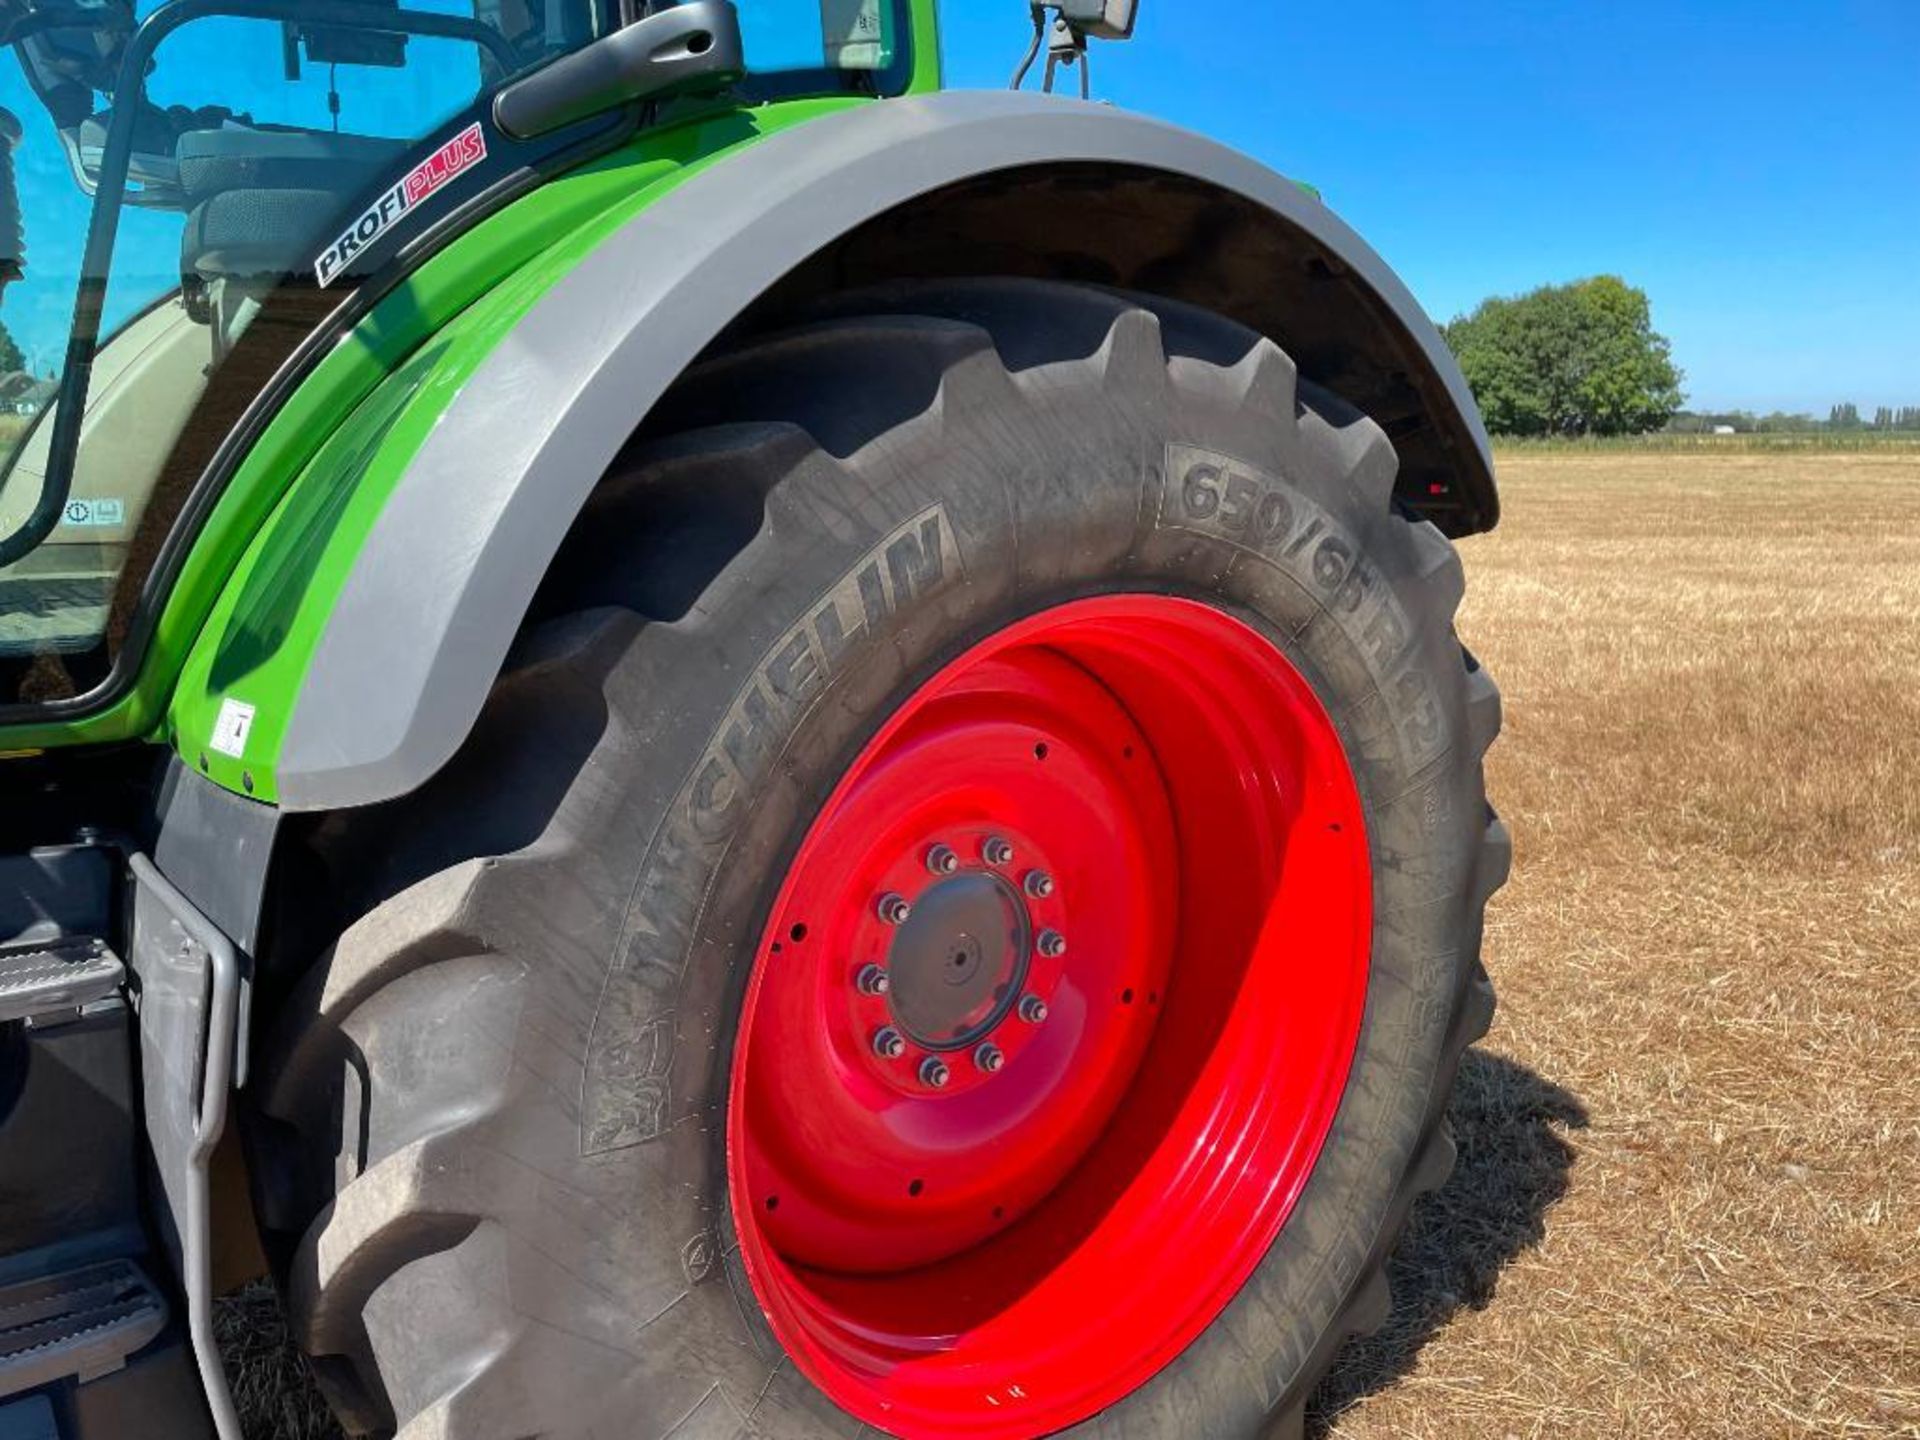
<box><xmin>945</xmin><ymin>0</ymin><xmax>1920</xmax><ymax>415</ymax></box>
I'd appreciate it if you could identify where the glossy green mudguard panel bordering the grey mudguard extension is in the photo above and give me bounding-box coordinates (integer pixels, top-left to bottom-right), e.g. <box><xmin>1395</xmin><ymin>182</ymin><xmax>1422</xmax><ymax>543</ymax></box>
<box><xmin>169</xmin><ymin>100</ymin><xmax>872</xmax><ymax>801</ymax></box>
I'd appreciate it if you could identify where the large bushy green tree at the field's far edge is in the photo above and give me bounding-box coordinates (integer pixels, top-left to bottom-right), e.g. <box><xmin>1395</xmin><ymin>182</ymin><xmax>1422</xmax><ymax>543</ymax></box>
<box><xmin>1446</xmin><ymin>275</ymin><xmax>1684</xmax><ymax>436</ymax></box>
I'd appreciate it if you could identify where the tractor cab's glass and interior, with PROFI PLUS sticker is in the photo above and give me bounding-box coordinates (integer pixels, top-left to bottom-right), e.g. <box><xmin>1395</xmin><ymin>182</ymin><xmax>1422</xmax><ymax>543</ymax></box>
<box><xmin>0</xmin><ymin>0</ymin><xmax>908</xmax><ymax>712</ymax></box>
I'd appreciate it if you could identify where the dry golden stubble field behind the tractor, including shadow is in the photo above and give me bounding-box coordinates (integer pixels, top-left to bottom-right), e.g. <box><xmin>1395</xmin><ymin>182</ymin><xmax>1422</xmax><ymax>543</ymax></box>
<box><xmin>217</xmin><ymin>453</ymin><xmax>1920</xmax><ymax>1440</ymax></box>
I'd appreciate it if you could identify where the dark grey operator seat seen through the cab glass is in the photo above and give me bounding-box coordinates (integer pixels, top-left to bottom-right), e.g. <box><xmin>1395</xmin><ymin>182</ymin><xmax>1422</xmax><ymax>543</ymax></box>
<box><xmin>175</xmin><ymin>125</ymin><xmax>407</xmax><ymax>280</ymax></box>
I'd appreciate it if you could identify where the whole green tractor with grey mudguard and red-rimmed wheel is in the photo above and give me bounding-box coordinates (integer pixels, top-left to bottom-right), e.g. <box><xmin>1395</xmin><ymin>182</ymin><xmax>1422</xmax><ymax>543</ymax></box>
<box><xmin>0</xmin><ymin>0</ymin><xmax>1509</xmax><ymax>1440</ymax></box>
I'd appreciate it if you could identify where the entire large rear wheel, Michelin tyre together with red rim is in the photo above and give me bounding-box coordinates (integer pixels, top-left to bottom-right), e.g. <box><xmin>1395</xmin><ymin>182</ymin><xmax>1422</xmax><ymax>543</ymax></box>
<box><xmin>255</xmin><ymin>282</ymin><xmax>1507</xmax><ymax>1440</ymax></box>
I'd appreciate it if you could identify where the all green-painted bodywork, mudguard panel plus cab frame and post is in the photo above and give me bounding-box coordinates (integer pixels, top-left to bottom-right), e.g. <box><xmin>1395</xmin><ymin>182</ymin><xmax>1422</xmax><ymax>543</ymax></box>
<box><xmin>0</xmin><ymin>0</ymin><xmax>941</xmax><ymax>801</ymax></box>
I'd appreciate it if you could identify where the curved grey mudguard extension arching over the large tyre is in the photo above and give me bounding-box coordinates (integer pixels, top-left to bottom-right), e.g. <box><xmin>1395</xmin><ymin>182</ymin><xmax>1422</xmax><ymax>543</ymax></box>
<box><xmin>278</xmin><ymin>92</ymin><xmax>1492</xmax><ymax>810</ymax></box>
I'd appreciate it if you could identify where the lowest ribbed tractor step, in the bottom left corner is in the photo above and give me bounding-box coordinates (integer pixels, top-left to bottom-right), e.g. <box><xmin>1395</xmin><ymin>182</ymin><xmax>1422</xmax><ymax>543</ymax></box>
<box><xmin>0</xmin><ymin>1260</ymin><xmax>167</xmax><ymax>1400</ymax></box>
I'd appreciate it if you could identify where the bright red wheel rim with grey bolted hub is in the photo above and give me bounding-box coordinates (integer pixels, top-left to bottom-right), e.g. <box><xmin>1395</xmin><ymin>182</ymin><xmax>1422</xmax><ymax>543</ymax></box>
<box><xmin>728</xmin><ymin>595</ymin><xmax>1371</xmax><ymax>1440</ymax></box>
